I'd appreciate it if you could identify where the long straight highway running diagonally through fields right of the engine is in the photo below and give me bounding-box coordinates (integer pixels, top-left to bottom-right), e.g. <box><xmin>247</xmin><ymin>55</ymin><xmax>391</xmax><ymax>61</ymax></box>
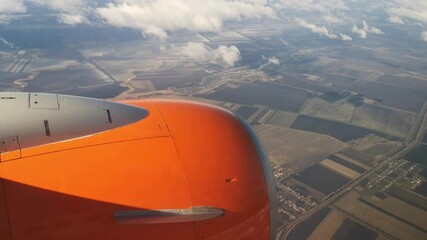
<box><xmin>276</xmin><ymin>102</ymin><xmax>427</xmax><ymax>240</ymax></box>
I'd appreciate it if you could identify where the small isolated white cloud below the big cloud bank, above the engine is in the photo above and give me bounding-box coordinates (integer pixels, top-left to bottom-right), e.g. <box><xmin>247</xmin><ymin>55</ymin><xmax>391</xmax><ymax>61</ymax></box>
<box><xmin>179</xmin><ymin>42</ymin><xmax>240</xmax><ymax>66</ymax></box>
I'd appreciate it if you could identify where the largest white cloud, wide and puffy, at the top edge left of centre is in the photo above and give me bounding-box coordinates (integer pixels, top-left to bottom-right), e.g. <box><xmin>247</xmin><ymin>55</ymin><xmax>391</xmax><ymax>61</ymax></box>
<box><xmin>96</xmin><ymin>0</ymin><xmax>275</xmax><ymax>38</ymax></box>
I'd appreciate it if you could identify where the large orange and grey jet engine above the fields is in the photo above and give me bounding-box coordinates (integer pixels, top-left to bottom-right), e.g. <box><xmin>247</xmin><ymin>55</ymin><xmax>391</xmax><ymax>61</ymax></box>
<box><xmin>0</xmin><ymin>93</ymin><xmax>277</xmax><ymax>240</ymax></box>
